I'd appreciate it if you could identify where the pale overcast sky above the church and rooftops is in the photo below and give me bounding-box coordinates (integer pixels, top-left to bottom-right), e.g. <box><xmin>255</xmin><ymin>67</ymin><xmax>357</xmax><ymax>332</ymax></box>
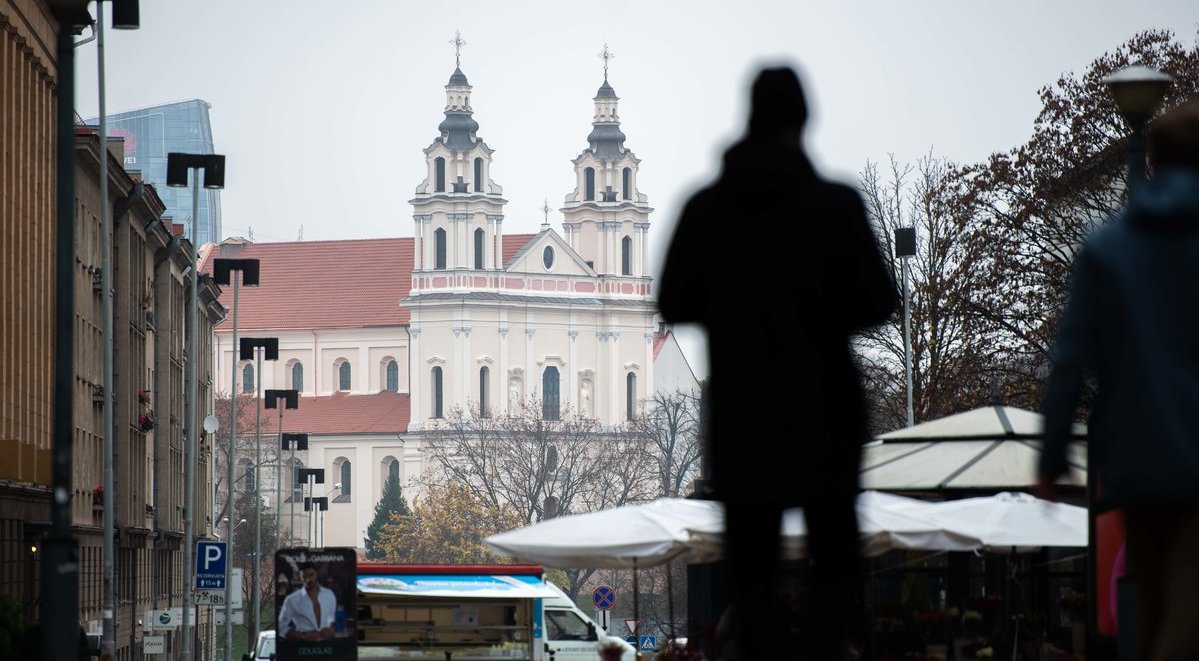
<box><xmin>77</xmin><ymin>0</ymin><xmax>1199</xmax><ymax>377</ymax></box>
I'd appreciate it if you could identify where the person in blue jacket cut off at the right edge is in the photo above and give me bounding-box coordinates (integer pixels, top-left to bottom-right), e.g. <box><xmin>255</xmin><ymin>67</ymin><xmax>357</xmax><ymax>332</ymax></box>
<box><xmin>1035</xmin><ymin>101</ymin><xmax>1199</xmax><ymax>661</ymax></box>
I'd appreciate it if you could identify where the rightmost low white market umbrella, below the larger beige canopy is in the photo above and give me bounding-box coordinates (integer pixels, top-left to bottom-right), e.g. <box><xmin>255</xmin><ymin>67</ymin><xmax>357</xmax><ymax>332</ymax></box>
<box><xmin>899</xmin><ymin>492</ymin><xmax>1089</xmax><ymax>551</ymax></box>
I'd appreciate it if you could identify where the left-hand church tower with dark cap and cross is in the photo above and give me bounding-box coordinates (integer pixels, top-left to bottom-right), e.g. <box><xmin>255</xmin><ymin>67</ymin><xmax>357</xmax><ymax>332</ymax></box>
<box><xmin>409</xmin><ymin>32</ymin><xmax>507</xmax><ymax>277</ymax></box>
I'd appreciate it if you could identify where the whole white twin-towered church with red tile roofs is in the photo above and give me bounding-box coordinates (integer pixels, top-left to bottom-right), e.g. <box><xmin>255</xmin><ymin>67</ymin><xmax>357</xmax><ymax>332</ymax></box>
<box><xmin>201</xmin><ymin>54</ymin><xmax>699</xmax><ymax>548</ymax></box>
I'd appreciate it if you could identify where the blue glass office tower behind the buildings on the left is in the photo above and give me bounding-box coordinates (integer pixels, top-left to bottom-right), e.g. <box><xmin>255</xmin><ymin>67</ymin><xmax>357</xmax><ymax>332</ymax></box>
<box><xmin>88</xmin><ymin>98</ymin><xmax>224</xmax><ymax>246</ymax></box>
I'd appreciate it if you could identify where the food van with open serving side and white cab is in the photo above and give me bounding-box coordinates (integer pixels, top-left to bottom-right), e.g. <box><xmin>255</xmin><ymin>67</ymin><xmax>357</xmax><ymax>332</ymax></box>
<box><xmin>356</xmin><ymin>563</ymin><xmax>637</xmax><ymax>661</ymax></box>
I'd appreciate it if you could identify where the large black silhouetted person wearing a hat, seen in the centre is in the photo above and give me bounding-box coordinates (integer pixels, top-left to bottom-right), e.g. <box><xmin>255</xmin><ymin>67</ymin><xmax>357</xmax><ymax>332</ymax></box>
<box><xmin>658</xmin><ymin>67</ymin><xmax>899</xmax><ymax>661</ymax></box>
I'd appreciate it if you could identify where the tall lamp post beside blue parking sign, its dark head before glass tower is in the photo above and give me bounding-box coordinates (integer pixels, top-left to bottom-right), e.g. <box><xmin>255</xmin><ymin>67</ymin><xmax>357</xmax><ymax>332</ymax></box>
<box><xmin>167</xmin><ymin>152</ymin><xmax>224</xmax><ymax>661</ymax></box>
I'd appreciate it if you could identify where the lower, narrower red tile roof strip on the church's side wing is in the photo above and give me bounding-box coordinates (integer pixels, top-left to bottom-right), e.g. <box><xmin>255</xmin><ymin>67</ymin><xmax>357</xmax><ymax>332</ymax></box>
<box><xmin>263</xmin><ymin>391</ymin><xmax>410</xmax><ymax>434</ymax></box>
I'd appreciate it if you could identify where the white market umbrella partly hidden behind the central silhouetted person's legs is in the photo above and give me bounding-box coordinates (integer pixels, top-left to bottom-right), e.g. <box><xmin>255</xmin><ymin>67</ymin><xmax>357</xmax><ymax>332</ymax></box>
<box><xmin>691</xmin><ymin>491</ymin><xmax>982</xmax><ymax>559</ymax></box>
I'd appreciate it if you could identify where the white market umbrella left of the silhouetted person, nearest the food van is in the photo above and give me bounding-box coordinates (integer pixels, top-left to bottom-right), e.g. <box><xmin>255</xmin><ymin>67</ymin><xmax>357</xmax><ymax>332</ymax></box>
<box><xmin>483</xmin><ymin>498</ymin><xmax>724</xmax><ymax>569</ymax></box>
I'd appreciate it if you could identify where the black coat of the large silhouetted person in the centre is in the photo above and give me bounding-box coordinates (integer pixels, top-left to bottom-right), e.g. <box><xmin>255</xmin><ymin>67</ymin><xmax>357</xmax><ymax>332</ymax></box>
<box><xmin>658</xmin><ymin>133</ymin><xmax>898</xmax><ymax>505</ymax></box>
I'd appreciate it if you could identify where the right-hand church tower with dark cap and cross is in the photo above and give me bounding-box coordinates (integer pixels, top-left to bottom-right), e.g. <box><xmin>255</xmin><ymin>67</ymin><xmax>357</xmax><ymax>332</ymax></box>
<box><xmin>561</xmin><ymin>43</ymin><xmax>653</xmax><ymax>278</ymax></box>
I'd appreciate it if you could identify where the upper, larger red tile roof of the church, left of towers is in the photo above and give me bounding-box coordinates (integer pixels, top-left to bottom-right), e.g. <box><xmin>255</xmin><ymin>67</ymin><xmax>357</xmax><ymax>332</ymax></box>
<box><xmin>200</xmin><ymin>238</ymin><xmax>414</xmax><ymax>331</ymax></box>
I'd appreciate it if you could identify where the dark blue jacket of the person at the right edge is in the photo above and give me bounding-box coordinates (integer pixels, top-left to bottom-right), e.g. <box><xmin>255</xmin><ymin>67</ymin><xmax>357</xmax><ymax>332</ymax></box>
<box><xmin>1040</xmin><ymin>169</ymin><xmax>1199</xmax><ymax>505</ymax></box>
